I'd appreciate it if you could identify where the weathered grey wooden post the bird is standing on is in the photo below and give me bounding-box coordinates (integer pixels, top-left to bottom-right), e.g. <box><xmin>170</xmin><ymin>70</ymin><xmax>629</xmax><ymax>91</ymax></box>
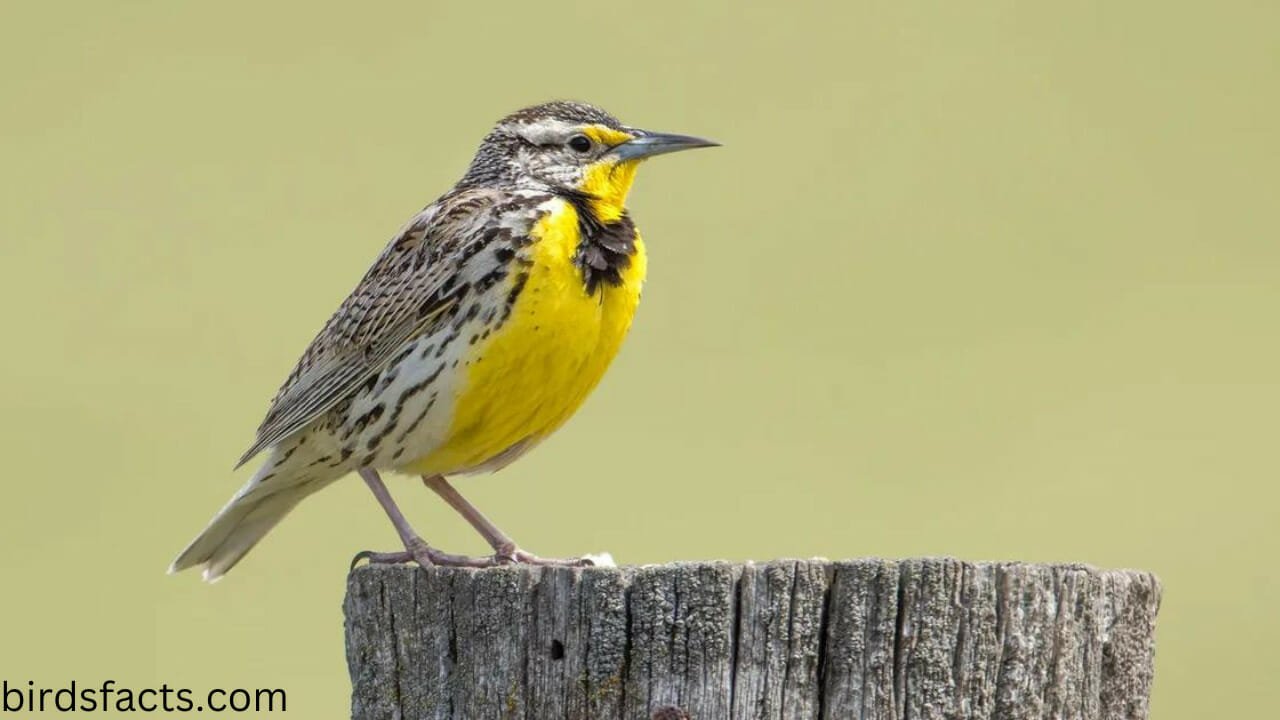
<box><xmin>346</xmin><ymin>559</ymin><xmax>1160</xmax><ymax>720</ymax></box>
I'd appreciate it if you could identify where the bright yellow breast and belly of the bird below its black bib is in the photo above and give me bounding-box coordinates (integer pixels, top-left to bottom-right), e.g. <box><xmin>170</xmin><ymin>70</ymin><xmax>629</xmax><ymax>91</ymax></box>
<box><xmin>407</xmin><ymin>200</ymin><xmax>645</xmax><ymax>474</ymax></box>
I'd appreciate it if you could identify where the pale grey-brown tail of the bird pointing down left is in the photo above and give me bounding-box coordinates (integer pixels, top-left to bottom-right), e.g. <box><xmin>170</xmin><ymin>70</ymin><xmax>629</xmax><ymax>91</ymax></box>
<box><xmin>169</xmin><ymin>450</ymin><xmax>332</xmax><ymax>583</ymax></box>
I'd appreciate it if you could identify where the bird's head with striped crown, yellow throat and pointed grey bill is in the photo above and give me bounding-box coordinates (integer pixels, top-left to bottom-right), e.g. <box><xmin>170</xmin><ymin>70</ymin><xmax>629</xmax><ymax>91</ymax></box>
<box><xmin>461</xmin><ymin>101</ymin><xmax>717</xmax><ymax>220</ymax></box>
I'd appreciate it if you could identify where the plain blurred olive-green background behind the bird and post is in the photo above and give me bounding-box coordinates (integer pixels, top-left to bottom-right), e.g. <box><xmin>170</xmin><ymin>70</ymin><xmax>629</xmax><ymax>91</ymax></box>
<box><xmin>0</xmin><ymin>1</ymin><xmax>1280</xmax><ymax>720</ymax></box>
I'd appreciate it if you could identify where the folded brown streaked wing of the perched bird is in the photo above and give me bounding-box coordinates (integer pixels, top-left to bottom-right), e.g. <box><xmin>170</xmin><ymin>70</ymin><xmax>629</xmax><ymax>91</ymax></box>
<box><xmin>236</xmin><ymin>190</ymin><xmax>495</xmax><ymax>468</ymax></box>
